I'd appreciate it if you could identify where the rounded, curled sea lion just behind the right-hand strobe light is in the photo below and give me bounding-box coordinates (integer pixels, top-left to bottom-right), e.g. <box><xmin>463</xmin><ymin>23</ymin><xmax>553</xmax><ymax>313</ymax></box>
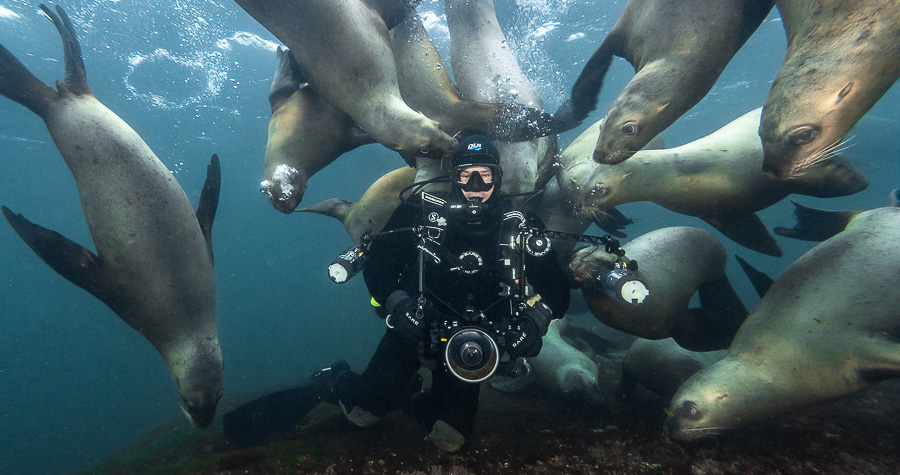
<box><xmin>569</xmin><ymin>227</ymin><xmax>747</xmax><ymax>351</ymax></box>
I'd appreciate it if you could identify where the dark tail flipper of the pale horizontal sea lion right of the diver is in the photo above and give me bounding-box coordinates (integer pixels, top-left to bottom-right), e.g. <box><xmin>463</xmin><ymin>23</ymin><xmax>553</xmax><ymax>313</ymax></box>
<box><xmin>787</xmin><ymin>156</ymin><xmax>869</xmax><ymax>198</ymax></box>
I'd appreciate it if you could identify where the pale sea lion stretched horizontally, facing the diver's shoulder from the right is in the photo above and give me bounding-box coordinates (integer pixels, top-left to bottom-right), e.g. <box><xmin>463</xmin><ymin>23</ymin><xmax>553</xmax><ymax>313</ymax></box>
<box><xmin>557</xmin><ymin>109</ymin><xmax>869</xmax><ymax>256</ymax></box>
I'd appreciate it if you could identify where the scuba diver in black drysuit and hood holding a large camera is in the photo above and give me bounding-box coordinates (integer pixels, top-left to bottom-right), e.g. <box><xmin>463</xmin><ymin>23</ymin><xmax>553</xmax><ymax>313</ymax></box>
<box><xmin>225</xmin><ymin>135</ymin><xmax>569</xmax><ymax>452</ymax></box>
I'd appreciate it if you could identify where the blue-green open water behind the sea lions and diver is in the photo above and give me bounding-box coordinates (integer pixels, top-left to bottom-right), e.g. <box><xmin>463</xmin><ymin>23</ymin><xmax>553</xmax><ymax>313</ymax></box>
<box><xmin>0</xmin><ymin>0</ymin><xmax>900</xmax><ymax>474</ymax></box>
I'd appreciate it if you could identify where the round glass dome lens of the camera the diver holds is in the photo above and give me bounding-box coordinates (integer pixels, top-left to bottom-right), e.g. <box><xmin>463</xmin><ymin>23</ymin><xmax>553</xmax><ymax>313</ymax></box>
<box><xmin>444</xmin><ymin>327</ymin><xmax>500</xmax><ymax>383</ymax></box>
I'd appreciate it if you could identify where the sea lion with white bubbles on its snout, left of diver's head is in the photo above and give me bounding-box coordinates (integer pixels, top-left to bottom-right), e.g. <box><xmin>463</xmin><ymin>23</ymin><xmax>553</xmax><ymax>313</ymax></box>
<box><xmin>260</xmin><ymin>47</ymin><xmax>373</xmax><ymax>213</ymax></box>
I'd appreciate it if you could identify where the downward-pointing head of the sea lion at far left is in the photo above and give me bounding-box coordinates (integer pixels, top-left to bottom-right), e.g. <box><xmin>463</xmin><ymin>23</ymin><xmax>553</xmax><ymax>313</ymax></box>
<box><xmin>166</xmin><ymin>338</ymin><xmax>225</xmax><ymax>429</ymax></box>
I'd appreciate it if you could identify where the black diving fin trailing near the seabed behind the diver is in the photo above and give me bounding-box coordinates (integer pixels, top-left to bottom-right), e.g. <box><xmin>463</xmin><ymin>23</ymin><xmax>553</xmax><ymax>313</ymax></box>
<box><xmin>222</xmin><ymin>361</ymin><xmax>350</xmax><ymax>448</ymax></box>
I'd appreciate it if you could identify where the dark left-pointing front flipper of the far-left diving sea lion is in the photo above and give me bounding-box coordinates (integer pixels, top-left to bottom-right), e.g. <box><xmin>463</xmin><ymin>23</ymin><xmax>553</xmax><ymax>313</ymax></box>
<box><xmin>2</xmin><ymin>206</ymin><xmax>120</xmax><ymax>311</ymax></box>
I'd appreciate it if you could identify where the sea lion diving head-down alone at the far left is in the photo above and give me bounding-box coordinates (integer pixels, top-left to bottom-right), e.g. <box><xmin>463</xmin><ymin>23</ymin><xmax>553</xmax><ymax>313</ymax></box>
<box><xmin>0</xmin><ymin>4</ymin><xmax>223</xmax><ymax>427</ymax></box>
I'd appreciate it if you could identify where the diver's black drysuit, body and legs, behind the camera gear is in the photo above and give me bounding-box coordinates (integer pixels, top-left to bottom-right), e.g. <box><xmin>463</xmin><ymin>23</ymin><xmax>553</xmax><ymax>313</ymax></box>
<box><xmin>336</xmin><ymin>194</ymin><xmax>569</xmax><ymax>436</ymax></box>
